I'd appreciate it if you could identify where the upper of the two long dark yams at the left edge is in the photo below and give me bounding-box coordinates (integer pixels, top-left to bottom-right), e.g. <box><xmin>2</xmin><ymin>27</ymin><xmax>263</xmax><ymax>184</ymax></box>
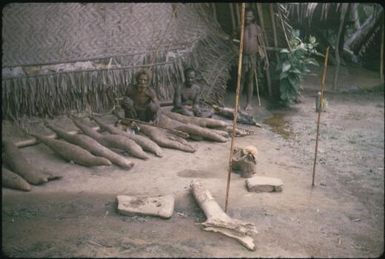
<box><xmin>2</xmin><ymin>140</ymin><xmax>61</xmax><ymax>185</ymax></box>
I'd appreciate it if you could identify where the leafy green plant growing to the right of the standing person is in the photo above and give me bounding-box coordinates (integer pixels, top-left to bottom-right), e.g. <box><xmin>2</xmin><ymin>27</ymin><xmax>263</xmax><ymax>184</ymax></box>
<box><xmin>277</xmin><ymin>31</ymin><xmax>320</xmax><ymax>105</ymax></box>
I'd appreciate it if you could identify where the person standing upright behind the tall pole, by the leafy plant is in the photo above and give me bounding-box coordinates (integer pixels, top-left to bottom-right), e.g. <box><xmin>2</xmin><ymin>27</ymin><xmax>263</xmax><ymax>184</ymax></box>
<box><xmin>240</xmin><ymin>8</ymin><xmax>266</xmax><ymax>111</ymax></box>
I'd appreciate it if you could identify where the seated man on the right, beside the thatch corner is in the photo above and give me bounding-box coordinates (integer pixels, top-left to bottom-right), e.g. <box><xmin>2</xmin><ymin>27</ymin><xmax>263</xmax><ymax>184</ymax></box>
<box><xmin>171</xmin><ymin>68</ymin><xmax>211</xmax><ymax>117</ymax></box>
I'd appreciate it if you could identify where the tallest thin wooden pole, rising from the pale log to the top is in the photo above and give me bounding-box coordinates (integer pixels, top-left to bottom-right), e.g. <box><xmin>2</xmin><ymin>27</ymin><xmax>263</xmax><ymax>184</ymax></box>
<box><xmin>225</xmin><ymin>3</ymin><xmax>245</xmax><ymax>212</ymax></box>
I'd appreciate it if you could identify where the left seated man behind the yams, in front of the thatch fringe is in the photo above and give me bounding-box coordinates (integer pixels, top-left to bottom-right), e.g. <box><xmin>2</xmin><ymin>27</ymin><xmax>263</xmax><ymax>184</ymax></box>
<box><xmin>121</xmin><ymin>70</ymin><xmax>160</xmax><ymax>123</ymax></box>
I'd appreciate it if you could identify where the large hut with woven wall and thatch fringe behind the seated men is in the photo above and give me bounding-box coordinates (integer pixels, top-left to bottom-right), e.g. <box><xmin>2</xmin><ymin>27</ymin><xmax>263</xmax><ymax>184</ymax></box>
<box><xmin>2</xmin><ymin>3</ymin><xmax>236</xmax><ymax>118</ymax></box>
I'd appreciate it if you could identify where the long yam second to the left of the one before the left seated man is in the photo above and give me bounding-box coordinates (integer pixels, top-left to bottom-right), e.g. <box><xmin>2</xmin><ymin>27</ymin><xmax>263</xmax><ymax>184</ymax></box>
<box><xmin>71</xmin><ymin>117</ymin><xmax>149</xmax><ymax>160</ymax></box>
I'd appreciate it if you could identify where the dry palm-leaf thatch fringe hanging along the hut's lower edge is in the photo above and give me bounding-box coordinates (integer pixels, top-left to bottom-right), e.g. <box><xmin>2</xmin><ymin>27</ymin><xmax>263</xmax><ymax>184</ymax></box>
<box><xmin>2</xmin><ymin>35</ymin><xmax>235</xmax><ymax>119</ymax></box>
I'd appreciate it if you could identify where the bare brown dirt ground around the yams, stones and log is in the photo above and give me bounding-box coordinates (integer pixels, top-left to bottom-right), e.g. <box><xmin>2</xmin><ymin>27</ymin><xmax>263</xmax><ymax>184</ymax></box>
<box><xmin>2</xmin><ymin>65</ymin><xmax>384</xmax><ymax>258</ymax></box>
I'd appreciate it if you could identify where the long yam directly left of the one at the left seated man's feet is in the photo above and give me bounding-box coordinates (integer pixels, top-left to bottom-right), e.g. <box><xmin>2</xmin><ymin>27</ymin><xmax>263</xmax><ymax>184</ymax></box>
<box><xmin>90</xmin><ymin>116</ymin><xmax>163</xmax><ymax>157</ymax></box>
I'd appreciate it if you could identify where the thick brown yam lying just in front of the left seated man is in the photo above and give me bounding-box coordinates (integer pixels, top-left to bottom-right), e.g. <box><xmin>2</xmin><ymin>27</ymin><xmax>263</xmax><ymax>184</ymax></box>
<box><xmin>136</xmin><ymin>124</ymin><xmax>195</xmax><ymax>153</ymax></box>
